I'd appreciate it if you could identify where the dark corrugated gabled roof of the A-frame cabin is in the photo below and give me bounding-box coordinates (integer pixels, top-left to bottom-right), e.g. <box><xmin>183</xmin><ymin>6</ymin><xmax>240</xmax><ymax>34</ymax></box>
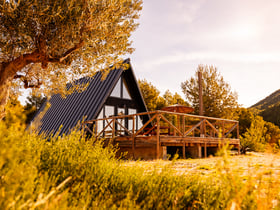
<box><xmin>35</xmin><ymin>60</ymin><xmax>147</xmax><ymax>135</ymax></box>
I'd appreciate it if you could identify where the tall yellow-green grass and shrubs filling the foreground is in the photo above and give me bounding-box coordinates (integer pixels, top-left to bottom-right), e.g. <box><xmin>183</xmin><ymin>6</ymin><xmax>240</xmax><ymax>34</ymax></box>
<box><xmin>0</xmin><ymin>122</ymin><xmax>280</xmax><ymax>209</ymax></box>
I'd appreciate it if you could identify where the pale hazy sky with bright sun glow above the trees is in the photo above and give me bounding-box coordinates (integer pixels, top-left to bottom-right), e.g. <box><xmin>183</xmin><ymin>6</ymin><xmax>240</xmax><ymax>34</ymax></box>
<box><xmin>130</xmin><ymin>0</ymin><xmax>280</xmax><ymax>107</ymax></box>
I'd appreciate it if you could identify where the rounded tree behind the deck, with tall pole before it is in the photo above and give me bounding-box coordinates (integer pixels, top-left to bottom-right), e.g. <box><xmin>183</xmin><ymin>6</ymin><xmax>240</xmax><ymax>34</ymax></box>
<box><xmin>181</xmin><ymin>65</ymin><xmax>238</xmax><ymax>118</ymax></box>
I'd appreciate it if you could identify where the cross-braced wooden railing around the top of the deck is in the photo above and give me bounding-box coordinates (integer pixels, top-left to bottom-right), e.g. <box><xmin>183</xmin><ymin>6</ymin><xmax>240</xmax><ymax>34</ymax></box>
<box><xmin>82</xmin><ymin>111</ymin><xmax>239</xmax><ymax>139</ymax></box>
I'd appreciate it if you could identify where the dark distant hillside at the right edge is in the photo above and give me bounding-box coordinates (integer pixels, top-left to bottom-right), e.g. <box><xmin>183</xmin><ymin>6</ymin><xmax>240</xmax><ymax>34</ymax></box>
<box><xmin>251</xmin><ymin>89</ymin><xmax>280</xmax><ymax>126</ymax></box>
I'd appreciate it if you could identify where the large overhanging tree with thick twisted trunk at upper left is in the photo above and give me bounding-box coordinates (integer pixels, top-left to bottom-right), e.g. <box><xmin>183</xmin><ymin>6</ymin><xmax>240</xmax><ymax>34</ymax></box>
<box><xmin>0</xmin><ymin>0</ymin><xmax>142</xmax><ymax>119</ymax></box>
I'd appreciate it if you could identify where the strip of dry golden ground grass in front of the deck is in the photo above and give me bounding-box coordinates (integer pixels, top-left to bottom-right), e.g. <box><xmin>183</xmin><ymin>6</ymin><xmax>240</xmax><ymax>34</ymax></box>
<box><xmin>123</xmin><ymin>152</ymin><xmax>280</xmax><ymax>177</ymax></box>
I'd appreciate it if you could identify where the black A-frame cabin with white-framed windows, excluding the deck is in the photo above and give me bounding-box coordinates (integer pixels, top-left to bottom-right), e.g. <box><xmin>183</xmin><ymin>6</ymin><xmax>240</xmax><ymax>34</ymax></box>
<box><xmin>34</xmin><ymin>59</ymin><xmax>147</xmax><ymax>135</ymax></box>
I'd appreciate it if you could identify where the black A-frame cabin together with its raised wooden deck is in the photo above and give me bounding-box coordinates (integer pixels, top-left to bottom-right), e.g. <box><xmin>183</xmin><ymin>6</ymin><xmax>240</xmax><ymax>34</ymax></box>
<box><xmin>35</xmin><ymin>60</ymin><xmax>240</xmax><ymax>159</ymax></box>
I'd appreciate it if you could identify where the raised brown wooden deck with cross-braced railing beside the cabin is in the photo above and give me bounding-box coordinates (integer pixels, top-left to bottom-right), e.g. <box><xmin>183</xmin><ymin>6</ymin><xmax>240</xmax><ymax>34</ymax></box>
<box><xmin>83</xmin><ymin>111</ymin><xmax>240</xmax><ymax>159</ymax></box>
